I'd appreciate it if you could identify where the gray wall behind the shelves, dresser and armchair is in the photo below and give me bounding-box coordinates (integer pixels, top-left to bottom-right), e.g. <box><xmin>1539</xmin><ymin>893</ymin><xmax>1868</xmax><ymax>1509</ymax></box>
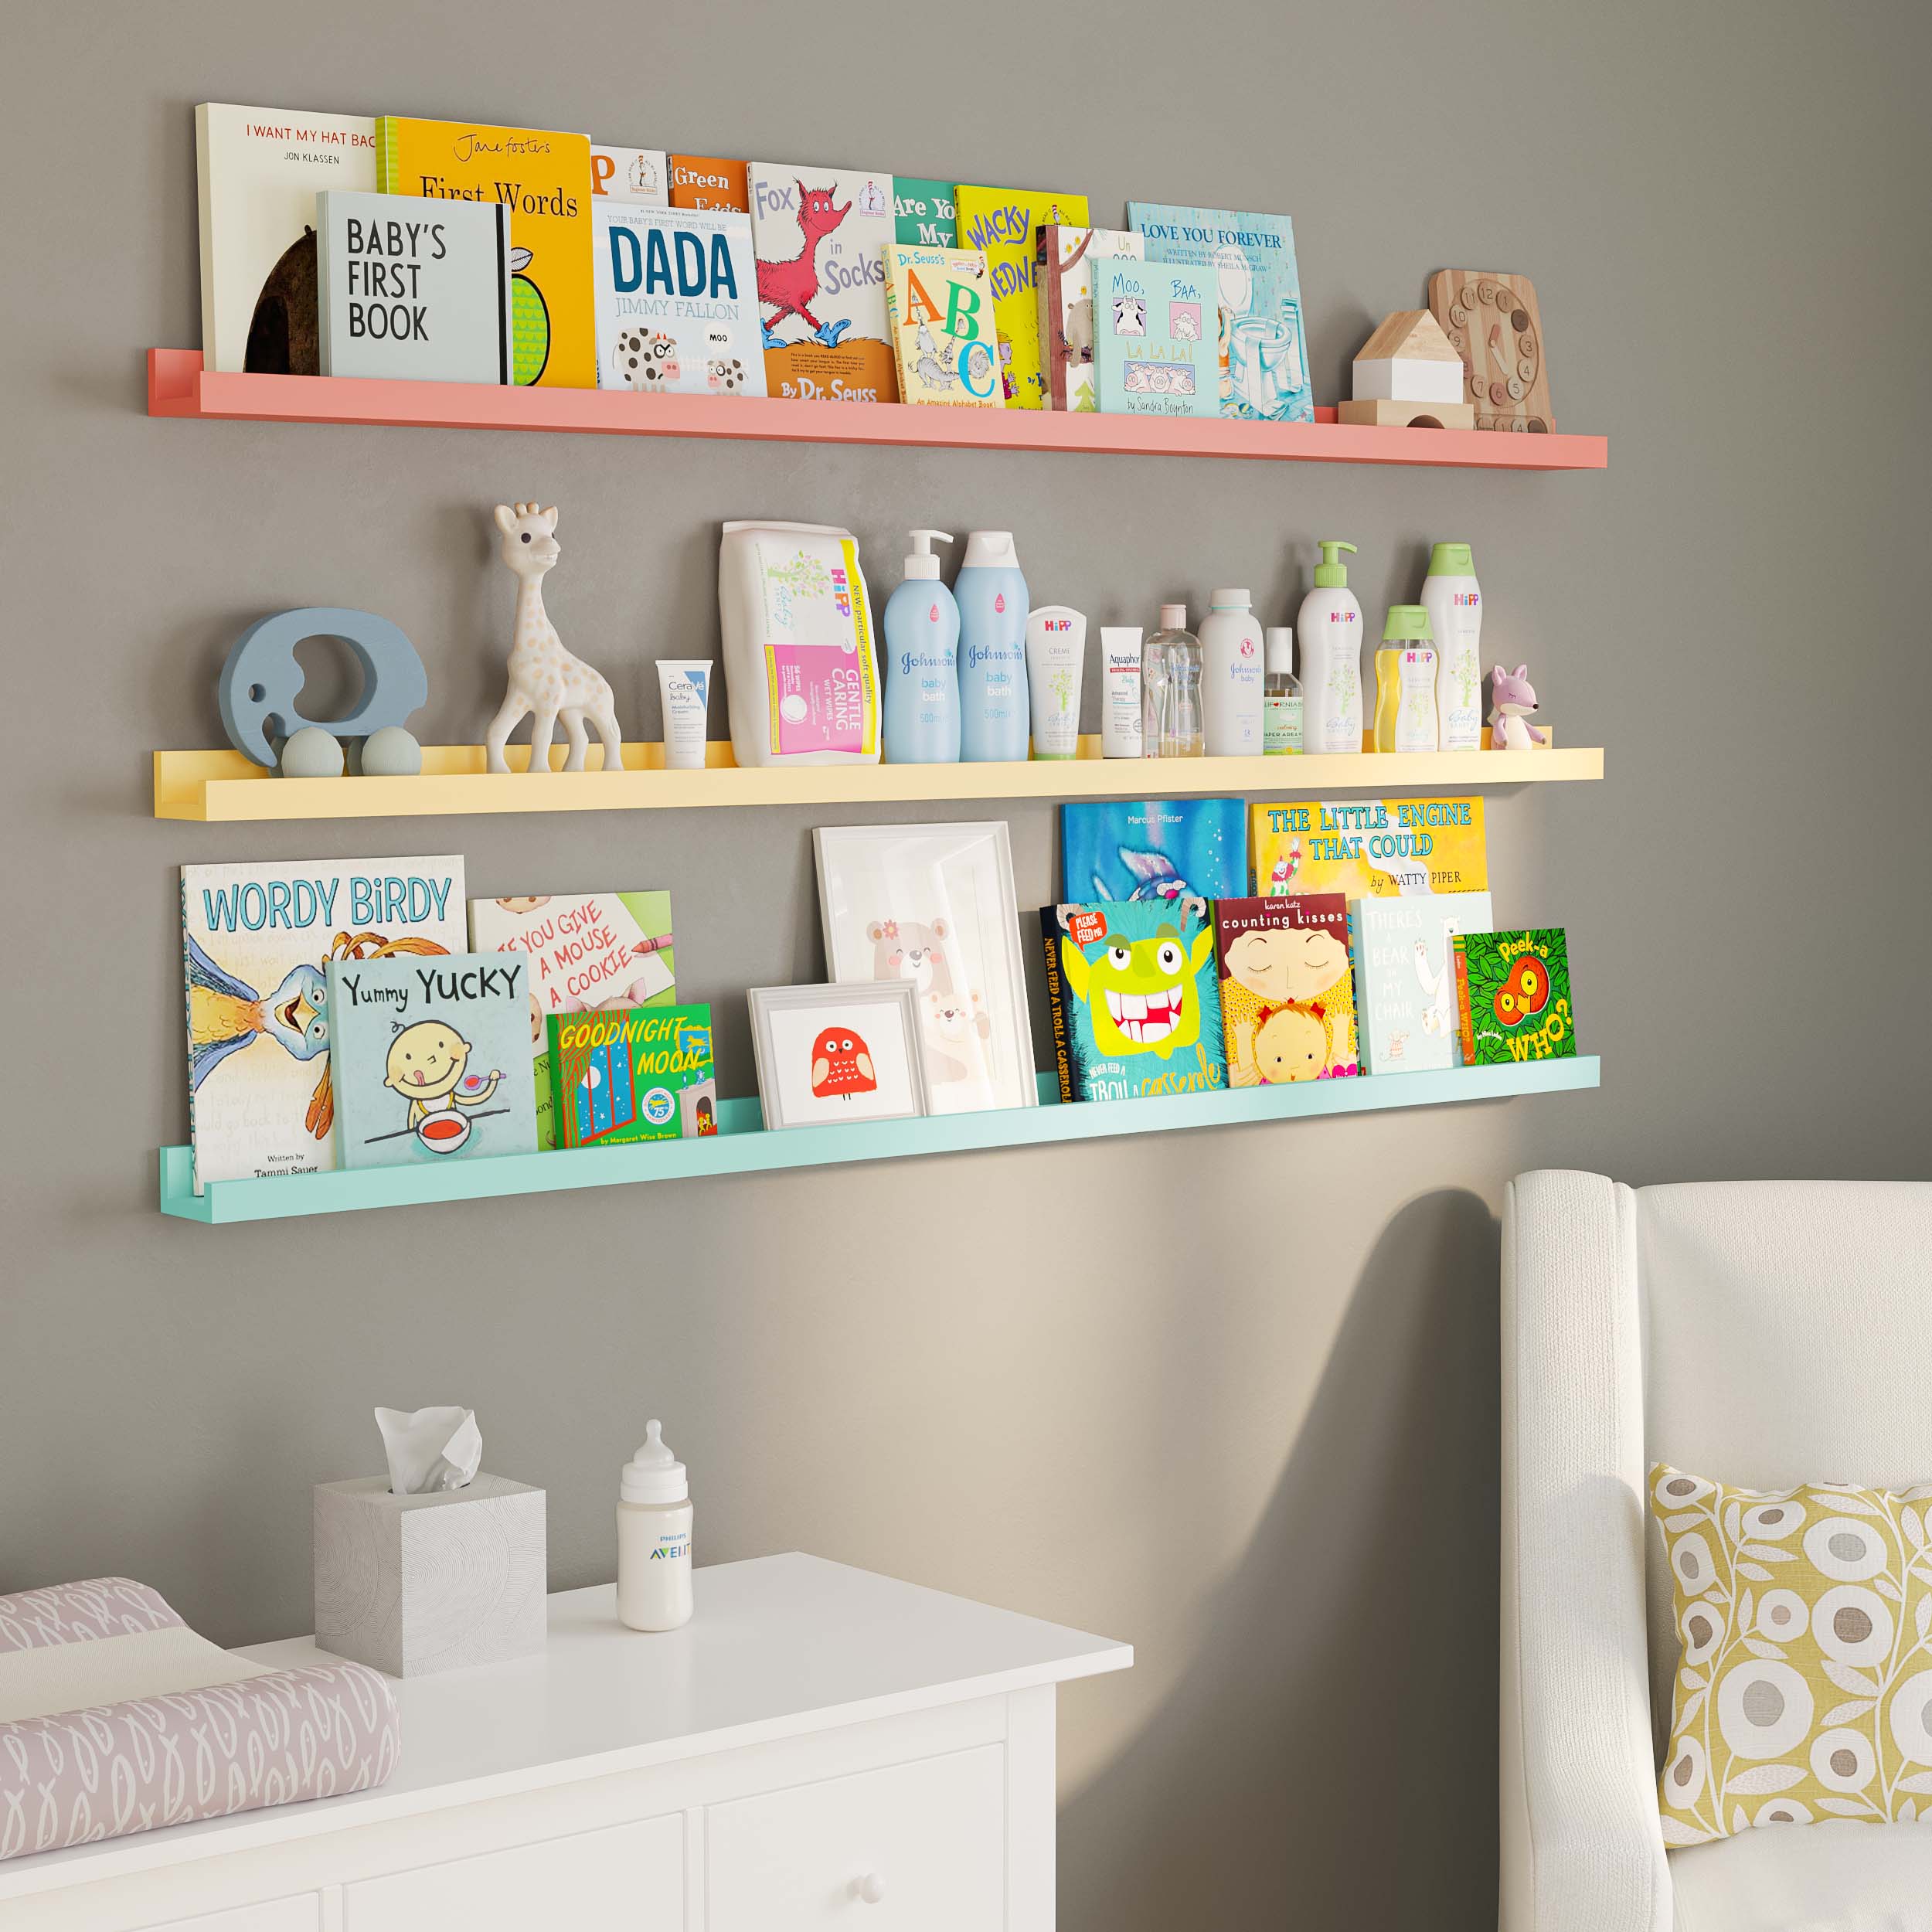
<box><xmin>11</xmin><ymin>0</ymin><xmax>1932</xmax><ymax>1932</ymax></box>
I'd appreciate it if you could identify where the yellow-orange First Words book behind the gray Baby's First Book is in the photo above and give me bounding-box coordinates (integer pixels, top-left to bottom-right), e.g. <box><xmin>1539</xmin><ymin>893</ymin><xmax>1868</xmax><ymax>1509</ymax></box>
<box><xmin>375</xmin><ymin>114</ymin><xmax>597</xmax><ymax>389</ymax></box>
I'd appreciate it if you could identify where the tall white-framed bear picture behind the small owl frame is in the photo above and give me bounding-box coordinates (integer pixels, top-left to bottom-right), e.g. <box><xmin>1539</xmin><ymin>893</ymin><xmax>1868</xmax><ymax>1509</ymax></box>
<box><xmin>811</xmin><ymin>819</ymin><xmax>1039</xmax><ymax>1115</ymax></box>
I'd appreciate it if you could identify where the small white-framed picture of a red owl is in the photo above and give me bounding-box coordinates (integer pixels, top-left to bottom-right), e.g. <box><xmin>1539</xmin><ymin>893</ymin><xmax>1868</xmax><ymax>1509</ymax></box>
<box><xmin>746</xmin><ymin>980</ymin><xmax>927</xmax><ymax>1131</ymax></box>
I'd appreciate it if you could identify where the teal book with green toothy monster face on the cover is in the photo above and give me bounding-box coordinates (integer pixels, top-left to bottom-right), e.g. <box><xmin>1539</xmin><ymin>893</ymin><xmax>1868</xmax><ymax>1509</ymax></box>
<box><xmin>1039</xmin><ymin>899</ymin><xmax>1227</xmax><ymax>1100</ymax></box>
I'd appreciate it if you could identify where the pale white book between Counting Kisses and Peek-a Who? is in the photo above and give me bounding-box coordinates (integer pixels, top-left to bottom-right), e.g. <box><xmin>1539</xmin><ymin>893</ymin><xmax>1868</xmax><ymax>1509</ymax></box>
<box><xmin>1345</xmin><ymin>893</ymin><xmax>1494</xmax><ymax>1074</ymax></box>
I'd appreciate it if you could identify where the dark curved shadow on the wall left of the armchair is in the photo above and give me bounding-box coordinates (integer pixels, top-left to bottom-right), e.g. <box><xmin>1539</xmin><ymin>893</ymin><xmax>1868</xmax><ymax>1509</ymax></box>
<box><xmin>1061</xmin><ymin>1190</ymin><xmax>1502</xmax><ymax>1932</ymax></box>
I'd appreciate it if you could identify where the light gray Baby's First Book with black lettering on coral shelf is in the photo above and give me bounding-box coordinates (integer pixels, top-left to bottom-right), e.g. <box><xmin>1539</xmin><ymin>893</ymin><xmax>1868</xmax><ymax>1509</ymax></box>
<box><xmin>315</xmin><ymin>189</ymin><xmax>516</xmax><ymax>383</ymax></box>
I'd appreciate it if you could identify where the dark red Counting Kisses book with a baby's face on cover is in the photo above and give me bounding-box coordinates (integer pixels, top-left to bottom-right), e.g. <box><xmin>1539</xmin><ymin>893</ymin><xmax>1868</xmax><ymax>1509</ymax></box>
<box><xmin>1213</xmin><ymin>893</ymin><xmax>1359</xmax><ymax>1086</ymax></box>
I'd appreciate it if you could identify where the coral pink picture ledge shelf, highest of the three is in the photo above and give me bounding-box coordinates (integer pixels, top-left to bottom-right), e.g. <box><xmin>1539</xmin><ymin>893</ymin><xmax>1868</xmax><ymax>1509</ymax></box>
<box><xmin>147</xmin><ymin>350</ymin><xmax>1610</xmax><ymax>470</ymax></box>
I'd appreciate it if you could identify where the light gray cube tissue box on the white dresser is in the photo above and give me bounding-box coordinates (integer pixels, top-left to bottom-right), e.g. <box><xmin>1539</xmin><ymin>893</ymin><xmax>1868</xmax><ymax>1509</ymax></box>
<box><xmin>315</xmin><ymin>1472</ymin><xmax>545</xmax><ymax>1677</ymax></box>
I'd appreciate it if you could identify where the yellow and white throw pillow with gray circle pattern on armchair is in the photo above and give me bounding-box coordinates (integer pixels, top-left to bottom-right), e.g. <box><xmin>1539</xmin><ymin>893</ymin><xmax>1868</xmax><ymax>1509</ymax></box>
<box><xmin>1650</xmin><ymin>1463</ymin><xmax>1932</xmax><ymax>1845</ymax></box>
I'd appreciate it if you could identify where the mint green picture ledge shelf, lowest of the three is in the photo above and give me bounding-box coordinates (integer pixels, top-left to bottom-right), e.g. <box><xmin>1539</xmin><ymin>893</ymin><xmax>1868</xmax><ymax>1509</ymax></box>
<box><xmin>161</xmin><ymin>1057</ymin><xmax>1598</xmax><ymax>1223</ymax></box>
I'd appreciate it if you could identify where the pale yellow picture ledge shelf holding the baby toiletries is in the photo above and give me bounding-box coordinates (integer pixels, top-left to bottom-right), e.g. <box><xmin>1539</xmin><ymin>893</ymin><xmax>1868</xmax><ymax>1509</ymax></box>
<box><xmin>155</xmin><ymin>738</ymin><xmax>1604</xmax><ymax>823</ymax></box>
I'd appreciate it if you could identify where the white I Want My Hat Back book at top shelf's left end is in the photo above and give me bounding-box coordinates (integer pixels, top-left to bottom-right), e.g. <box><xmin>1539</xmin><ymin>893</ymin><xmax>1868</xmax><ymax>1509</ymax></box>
<box><xmin>196</xmin><ymin>100</ymin><xmax>375</xmax><ymax>375</ymax></box>
